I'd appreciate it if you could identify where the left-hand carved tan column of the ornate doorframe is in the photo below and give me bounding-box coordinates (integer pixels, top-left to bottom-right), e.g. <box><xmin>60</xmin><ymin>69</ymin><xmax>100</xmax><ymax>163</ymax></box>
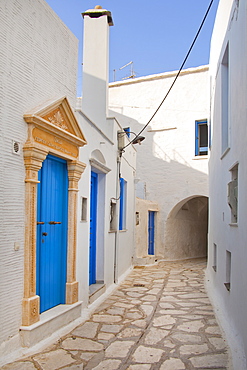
<box><xmin>22</xmin><ymin>145</ymin><xmax>48</xmax><ymax>326</ymax></box>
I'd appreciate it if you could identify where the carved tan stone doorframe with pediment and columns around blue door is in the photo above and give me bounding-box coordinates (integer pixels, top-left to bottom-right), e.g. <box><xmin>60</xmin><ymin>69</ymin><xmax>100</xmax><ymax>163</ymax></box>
<box><xmin>22</xmin><ymin>98</ymin><xmax>86</xmax><ymax>326</ymax></box>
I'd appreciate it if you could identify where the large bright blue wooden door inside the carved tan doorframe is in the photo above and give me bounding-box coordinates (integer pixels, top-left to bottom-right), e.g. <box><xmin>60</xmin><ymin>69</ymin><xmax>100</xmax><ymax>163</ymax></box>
<box><xmin>36</xmin><ymin>155</ymin><xmax>68</xmax><ymax>312</ymax></box>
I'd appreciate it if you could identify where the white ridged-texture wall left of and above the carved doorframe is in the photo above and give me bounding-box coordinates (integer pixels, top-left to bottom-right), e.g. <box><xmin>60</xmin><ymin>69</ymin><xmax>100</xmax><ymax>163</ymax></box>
<box><xmin>0</xmin><ymin>0</ymin><xmax>78</xmax><ymax>357</ymax></box>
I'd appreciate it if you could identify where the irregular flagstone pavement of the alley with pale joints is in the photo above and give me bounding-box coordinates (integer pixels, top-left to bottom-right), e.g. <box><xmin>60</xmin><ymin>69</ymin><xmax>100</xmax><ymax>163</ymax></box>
<box><xmin>2</xmin><ymin>259</ymin><xmax>231</xmax><ymax>370</ymax></box>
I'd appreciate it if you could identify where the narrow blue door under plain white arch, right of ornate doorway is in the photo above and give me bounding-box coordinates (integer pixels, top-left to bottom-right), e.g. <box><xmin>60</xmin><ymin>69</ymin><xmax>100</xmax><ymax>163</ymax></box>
<box><xmin>89</xmin><ymin>171</ymin><xmax>98</xmax><ymax>285</ymax></box>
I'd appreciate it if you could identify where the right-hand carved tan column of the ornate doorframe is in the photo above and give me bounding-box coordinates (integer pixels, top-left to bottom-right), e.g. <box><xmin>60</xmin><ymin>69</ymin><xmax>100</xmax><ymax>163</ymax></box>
<box><xmin>66</xmin><ymin>160</ymin><xmax>86</xmax><ymax>304</ymax></box>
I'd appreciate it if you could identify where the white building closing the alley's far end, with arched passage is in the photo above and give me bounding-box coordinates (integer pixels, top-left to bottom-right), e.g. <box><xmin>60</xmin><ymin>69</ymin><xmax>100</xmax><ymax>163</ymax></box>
<box><xmin>109</xmin><ymin>66</ymin><xmax>209</xmax><ymax>263</ymax></box>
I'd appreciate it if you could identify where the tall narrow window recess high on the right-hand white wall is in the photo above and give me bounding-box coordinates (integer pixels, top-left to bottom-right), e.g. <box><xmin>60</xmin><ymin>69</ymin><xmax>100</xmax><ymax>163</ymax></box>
<box><xmin>221</xmin><ymin>45</ymin><xmax>229</xmax><ymax>154</ymax></box>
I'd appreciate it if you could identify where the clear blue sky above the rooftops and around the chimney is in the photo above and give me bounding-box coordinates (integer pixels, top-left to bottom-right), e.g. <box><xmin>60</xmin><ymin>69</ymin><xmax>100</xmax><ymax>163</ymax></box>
<box><xmin>46</xmin><ymin>0</ymin><xmax>219</xmax><ymax>95</ymax></box>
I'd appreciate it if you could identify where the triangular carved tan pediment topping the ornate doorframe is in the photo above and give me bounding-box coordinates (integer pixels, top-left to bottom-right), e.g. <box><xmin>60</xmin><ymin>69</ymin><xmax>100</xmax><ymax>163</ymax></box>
<box><xmin>24</xmin><ymin>97</ymin><xmax>87</xmax><ymax>146</ymax></box>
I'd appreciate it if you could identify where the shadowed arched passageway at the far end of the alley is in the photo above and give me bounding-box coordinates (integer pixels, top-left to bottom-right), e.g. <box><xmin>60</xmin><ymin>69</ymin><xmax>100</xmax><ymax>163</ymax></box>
<box><xmin>165</xmin><ymin>196</ymin><xmax>208</xmax><ymax>260</ymax></box>
